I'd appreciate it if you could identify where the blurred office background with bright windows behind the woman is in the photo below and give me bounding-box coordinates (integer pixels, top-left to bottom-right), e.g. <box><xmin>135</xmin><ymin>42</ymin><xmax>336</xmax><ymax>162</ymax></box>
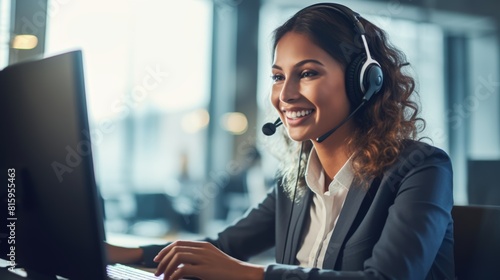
<box><xmin>0</xmin><ymin>0</ymin><xmax>500</xmax><ymax>241</ymax></box>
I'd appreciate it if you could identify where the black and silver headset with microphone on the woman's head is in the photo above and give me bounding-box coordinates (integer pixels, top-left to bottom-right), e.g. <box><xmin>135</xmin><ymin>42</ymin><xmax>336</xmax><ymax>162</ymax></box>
<box><xmin>262</xmin><ymin>3</ymin><xmax>384</xmax><ymax>143</ymax></box>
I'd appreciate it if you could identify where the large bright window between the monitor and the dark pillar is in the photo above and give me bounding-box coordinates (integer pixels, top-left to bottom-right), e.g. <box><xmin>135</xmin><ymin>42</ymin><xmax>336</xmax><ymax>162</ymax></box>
<box><xmin>46</xmin><ymin>0</ymin><xmax>212</xmax><ymax>235</ymax></box>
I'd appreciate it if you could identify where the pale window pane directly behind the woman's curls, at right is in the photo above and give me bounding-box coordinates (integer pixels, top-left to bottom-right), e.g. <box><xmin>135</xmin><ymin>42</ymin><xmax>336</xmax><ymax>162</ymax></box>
<box><xmin>374</xmin><ymin>16</ymin><xmax>449</xmax><ymax>152</ymax></box>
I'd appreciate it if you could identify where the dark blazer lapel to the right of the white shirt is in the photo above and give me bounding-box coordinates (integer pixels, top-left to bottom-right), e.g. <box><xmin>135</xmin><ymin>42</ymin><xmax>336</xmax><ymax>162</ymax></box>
<box><xmin>323</xmin><ymin>179</ymin><xmax>366</xmax><ymax>269</ymax></box>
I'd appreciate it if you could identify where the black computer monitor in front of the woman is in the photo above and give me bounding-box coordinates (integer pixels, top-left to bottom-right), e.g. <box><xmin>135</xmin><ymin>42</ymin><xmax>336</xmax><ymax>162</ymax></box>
<box><xmin>0</xmin><ymin>51</ymin><xmax>106</xmax><ymax>279</ymax></box>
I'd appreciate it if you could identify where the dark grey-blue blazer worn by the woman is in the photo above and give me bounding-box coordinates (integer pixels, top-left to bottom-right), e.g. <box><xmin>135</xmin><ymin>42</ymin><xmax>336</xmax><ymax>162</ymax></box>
<box><xmin>143</xmin><ymin>141</ymin><xmax>454</xmax><ymax>280</ymax></box>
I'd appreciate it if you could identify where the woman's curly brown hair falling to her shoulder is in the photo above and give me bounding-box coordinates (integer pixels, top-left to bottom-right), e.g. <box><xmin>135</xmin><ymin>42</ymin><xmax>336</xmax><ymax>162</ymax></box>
<box><xmin>273</xmin><ymin>3</ymin><xmax>425</xmax><ymax>198</ymax></box>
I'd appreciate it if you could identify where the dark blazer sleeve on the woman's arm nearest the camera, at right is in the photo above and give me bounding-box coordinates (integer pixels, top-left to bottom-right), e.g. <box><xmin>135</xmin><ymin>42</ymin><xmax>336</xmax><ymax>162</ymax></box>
<box><xmin>265</xmin><ymin>144</ymin><xmax>453</xmax><ymax>280</ymax></box>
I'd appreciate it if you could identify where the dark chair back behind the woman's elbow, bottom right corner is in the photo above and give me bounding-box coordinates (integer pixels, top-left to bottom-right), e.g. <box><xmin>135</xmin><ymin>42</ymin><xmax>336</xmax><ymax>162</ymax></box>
<box><xmin>452</xmin><ymin>205</ymin><xmax>500</xmax><ymax>280</ymax></box>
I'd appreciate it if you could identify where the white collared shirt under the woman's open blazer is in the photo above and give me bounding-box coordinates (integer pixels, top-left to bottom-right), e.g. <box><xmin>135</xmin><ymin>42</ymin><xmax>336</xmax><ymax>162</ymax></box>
<box><xmin>296</xmin><ymin>148</ymin><xmax>354</xmax><ymax>268</ymax></box>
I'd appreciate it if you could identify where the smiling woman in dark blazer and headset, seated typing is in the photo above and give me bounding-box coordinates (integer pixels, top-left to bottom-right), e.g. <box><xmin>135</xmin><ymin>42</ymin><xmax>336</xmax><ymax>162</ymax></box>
<box><xmin>109</xmin><ymin>3</ymin><xmax>454</xmax><ymax>279</ymax></box>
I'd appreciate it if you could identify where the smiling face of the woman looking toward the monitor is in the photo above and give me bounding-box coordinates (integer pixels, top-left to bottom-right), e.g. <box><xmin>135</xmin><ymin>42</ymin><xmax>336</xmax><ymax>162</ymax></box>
<box><xmin>271</xmin><ymin>32</ymin><xmax>350</xmax><ymax>141</ymax></box>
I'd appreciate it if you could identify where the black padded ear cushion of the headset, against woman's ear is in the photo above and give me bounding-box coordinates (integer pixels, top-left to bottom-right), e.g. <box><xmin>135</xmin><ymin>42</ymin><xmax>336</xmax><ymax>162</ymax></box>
<box><xmin>345</xmin><ymin>54</ymin><xmax>366</xmax><ymax>108</ymax></box>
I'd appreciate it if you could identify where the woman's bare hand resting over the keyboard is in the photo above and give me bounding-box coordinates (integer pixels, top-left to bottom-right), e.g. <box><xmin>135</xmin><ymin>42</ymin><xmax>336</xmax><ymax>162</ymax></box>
<box><xmin>154</xmin><ymin>241</ymin><xmax>264</xmax><ymax>280</ymax></box>
